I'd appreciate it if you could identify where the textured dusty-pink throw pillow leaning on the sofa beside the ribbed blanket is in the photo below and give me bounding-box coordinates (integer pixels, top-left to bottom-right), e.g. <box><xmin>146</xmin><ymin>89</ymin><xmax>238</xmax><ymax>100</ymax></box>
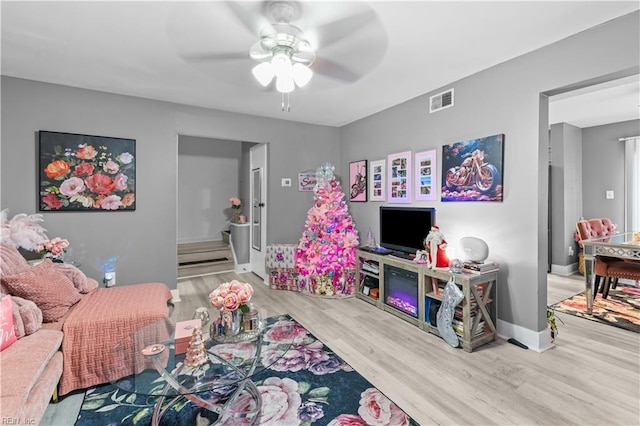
<box><xmin>2</xmin><ymin>259</ymin><xmax>82</xmax><ymax>322</ymax></box>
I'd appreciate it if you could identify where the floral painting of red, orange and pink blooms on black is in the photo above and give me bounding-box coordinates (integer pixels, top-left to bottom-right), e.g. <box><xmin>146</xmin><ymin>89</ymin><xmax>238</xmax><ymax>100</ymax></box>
<box><xmin>38</xmin><ymin>131</ymin><xmax>136</xmax><ymax>212</ymax></box>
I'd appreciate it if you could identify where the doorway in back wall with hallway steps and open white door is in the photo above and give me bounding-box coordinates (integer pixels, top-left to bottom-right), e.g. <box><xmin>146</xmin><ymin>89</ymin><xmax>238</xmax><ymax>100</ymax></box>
<box><xmin>176</xmin><ymin>135</ymin><xmax>267</xmax><ymax>277</ymax></box>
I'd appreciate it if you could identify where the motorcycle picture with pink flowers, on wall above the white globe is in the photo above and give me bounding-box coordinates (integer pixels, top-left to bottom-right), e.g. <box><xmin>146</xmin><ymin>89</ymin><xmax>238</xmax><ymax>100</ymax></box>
<box><xmin>440</xmin><ymin>134</ymin><xmax>504</xmax><ymax>201</ymax></box>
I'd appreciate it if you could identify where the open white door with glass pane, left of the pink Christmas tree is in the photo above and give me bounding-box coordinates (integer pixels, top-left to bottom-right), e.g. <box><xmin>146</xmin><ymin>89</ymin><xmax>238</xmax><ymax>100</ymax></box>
<box><xmin>249</xmin><ymin>143</ymin><xmax>269</xmax><ymax>282</ymax></box>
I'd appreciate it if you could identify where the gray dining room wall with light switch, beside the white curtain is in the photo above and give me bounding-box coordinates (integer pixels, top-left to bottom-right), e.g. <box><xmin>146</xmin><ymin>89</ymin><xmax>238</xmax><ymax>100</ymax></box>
<box><xmin>582</xmin><ymin>120</ymin><xmax>640</xmax><ymax>228</ymax></box>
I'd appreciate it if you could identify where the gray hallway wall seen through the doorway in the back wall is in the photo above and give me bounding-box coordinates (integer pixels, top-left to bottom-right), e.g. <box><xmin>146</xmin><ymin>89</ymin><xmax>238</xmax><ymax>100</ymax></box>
<box><xmin>177</xmin><ymin>135</ymin><xmax>241</xmax><ymax>243</ymax></box>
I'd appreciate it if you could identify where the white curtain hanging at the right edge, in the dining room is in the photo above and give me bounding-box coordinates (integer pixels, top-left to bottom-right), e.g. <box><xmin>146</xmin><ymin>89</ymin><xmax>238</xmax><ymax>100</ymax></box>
<box><xmin>620</xmin><ymin>136</ymin><xmax>640</xmax><ymax>232</ymax></box>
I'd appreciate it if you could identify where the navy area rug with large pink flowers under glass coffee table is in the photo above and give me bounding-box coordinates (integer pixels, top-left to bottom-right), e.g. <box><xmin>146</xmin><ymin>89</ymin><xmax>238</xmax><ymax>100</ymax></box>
<box><xmin>76</xmin><ymin>315</ymin><xmax>418</xmax><ymax>426</ymax></box>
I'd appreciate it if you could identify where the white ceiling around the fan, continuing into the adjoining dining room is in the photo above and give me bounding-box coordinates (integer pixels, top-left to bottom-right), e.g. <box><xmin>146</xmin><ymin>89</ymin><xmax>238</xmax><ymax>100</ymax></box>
<box><xmin>1</xmin><ymin>1</ymin><xmax>640</xmax><ymax>127</ymax></box>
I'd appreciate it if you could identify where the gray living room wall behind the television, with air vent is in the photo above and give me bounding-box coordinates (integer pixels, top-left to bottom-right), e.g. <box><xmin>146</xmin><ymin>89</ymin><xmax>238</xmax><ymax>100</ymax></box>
<box><xmin>340</xmin><ymin>13</ymin><xmax>640</xmax><ymax>344</ymax></box>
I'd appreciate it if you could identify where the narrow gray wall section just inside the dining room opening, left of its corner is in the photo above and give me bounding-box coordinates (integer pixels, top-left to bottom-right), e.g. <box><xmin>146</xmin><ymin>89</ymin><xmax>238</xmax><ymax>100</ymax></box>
<box><xmin>550</xmin><ymin>123</ymin><xmax>582</xmax><ymax>273</ymax></box>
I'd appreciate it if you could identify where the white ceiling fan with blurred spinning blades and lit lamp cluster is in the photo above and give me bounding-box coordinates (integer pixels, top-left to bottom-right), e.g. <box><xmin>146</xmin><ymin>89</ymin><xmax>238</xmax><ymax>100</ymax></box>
<box><xmin>167</xmin><ymin>0</ymin><xmax>387</xmax><ymax>110</ymax></box>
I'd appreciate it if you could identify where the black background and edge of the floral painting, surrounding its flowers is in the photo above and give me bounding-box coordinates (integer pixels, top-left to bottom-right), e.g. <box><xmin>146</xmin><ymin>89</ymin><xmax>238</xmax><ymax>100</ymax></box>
<box><xmin>36</xmin><ymin>130</ymin><xmax>137</xmax><ymax>212</ymax></box>
